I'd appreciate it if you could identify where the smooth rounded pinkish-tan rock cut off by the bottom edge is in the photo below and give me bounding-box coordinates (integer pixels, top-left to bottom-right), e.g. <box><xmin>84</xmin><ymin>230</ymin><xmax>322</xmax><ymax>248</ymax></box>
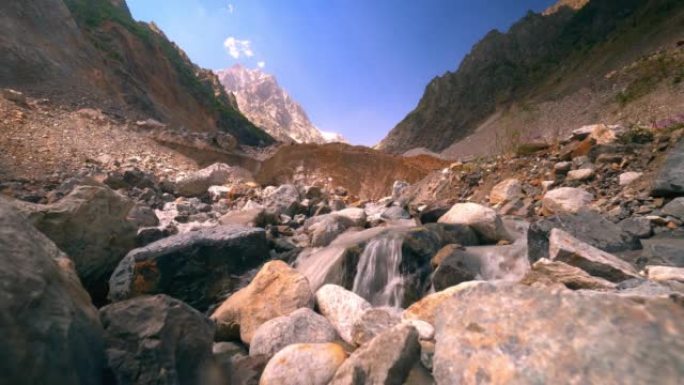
<box><xmin>259</xmin><ymin>343</ymin><xmax>347</xmax><ymax>385</ymax></box>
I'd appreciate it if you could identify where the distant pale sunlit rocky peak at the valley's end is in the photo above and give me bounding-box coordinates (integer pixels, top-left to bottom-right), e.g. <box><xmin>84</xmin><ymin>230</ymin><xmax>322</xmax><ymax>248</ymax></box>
<box><xmin>216</xmin><ymin>64</ymin><xmax>344</xmax><ymax>143</ymax></box>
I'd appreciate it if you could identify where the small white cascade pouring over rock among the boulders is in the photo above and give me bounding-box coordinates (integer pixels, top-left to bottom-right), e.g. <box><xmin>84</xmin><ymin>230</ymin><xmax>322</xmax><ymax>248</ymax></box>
<box><xmin>352</xmin><ymin>235</ymin><xmax>404</xmax><ymax>307</ymax></box>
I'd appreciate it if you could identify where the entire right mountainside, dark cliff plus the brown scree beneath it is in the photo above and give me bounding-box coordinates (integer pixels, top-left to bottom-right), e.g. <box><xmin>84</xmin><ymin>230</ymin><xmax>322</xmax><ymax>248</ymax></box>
<box><xmin>379</xmin><ymin>0</ymin><xmax>684</xmax><ymax>158</ymax></box>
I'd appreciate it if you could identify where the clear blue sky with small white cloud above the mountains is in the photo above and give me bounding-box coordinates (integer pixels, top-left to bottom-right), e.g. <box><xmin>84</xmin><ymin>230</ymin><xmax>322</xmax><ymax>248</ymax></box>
<box><xmin>127</xmin><ymin>0</ymin><xmax>555</xmax><ymax>145</ymax></box>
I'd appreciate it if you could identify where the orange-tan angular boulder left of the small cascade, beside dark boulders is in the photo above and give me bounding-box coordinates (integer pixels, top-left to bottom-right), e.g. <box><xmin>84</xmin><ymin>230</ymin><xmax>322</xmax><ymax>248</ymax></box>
<box><xmin>211</xmin><ymin>261</ymin><xmax>313</xmax><ymax>344</ymax></box>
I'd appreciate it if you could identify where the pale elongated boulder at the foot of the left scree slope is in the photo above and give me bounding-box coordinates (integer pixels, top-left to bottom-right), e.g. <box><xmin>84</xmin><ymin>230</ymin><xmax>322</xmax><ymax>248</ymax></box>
<box><xmin>176</xmin><ymin>163</ymin><xmax>254</xmax><ymax>197</ymax></box>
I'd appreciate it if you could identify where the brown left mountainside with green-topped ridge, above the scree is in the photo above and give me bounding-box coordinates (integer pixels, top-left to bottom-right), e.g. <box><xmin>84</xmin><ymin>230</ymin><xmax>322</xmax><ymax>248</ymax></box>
<box><xmin>0</xmin><ymin>0</ymin><xmax>273</xmax><ymax>145</ymax></box>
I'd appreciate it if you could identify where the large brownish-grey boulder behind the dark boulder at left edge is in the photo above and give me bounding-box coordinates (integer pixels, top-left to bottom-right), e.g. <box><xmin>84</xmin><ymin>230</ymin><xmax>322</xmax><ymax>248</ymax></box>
<box><xmin>17</xmin><ymin>186</ymin><xmax>137</xmax><ymax>305</ymax></box>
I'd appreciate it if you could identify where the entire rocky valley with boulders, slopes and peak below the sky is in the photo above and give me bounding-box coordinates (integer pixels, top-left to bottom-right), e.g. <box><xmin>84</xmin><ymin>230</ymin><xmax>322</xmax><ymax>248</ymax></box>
<box><xmin>0</xmin><ymin>0</ymin><xmax>684</xmax><ymax>385</ymax></box>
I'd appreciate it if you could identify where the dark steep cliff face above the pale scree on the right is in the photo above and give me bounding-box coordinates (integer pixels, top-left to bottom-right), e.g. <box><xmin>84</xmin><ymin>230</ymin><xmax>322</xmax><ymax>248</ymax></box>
<box><xmin>379</xmin><ymin>0</ymin><xmax>684</xmax><ymax>153</ymax></box>
